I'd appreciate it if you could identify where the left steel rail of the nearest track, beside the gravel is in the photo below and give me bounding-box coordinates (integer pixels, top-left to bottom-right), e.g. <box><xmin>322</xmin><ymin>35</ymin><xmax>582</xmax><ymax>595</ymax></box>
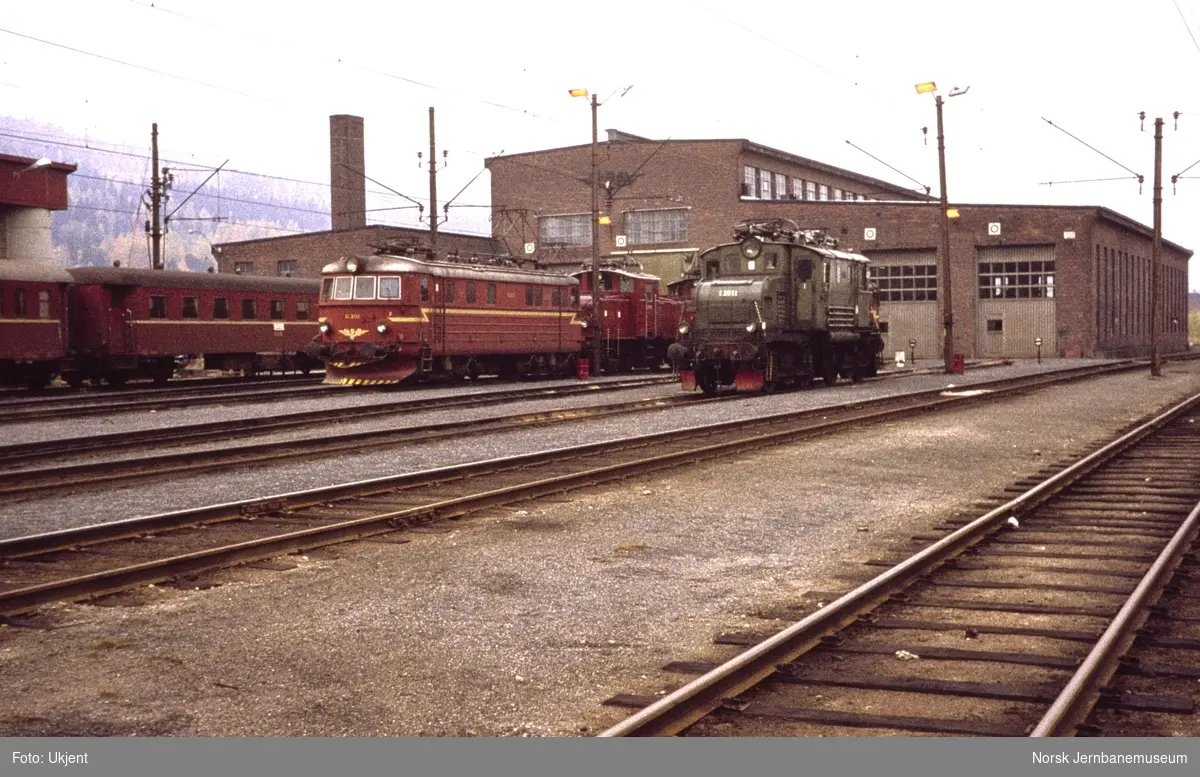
<box><xmin>599</xmin><ymin>394</ymin><xmax>1200</xmax><ymax>737</ymax></box>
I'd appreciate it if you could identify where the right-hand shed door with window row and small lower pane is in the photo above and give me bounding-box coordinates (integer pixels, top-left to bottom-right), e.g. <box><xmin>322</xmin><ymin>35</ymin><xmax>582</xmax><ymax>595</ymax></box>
<box><xmin>976</xmin><ymin>246</ymin><xmax>1058</xmax><ymax>359</ymax></box>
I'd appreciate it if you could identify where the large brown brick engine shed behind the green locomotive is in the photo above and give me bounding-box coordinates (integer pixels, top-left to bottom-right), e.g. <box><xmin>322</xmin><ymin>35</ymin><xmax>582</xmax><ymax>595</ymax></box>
<box><xmin>487</xmin><ymin>131</ymin><xmax>1192</xmax><ymax>357</ymax></box>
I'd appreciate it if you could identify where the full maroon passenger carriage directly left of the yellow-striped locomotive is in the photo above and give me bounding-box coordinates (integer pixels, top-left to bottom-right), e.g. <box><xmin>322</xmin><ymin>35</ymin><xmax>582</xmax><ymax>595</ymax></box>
<box><xmin>62</xmin><ymin>267</ymin><xmax>319</xmax><ymax>386</ymax></box>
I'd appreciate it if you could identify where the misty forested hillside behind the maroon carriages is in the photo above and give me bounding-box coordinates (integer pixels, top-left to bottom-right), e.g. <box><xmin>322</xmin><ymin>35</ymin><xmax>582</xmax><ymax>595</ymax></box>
<box><xmin>0</xmin><ymin>116</ymin><xmax>329</xmax><ymax>271</ymax></box>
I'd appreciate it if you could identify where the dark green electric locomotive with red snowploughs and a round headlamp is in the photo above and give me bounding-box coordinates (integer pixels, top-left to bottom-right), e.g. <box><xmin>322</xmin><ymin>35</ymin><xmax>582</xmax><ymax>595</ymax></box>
<box><xmin>668</xmin><ymin>219</ymin><xmax>883</xmax><ymax>394</ymax></box>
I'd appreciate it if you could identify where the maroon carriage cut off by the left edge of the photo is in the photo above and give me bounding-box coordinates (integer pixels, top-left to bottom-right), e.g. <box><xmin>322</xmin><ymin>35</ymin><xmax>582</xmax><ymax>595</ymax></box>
<box><xmin>0</xmin><ymin>259</ymin><xmax>71</xmax><ymax>390</ymax></box>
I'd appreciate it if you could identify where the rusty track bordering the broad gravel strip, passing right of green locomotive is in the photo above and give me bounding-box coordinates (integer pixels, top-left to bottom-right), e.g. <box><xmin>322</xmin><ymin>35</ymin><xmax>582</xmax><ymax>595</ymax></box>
<box><xmin>0</xmin><ymin>366</ymin><xmax>1142</xmax><ymax>615</ymax></box>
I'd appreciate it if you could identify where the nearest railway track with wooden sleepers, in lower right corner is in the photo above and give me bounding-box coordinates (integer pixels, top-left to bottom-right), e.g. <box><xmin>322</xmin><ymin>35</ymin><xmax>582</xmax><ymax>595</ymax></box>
<box><xmin>601</xmin><ymin>394</ymin><xmax>1200</xmax><ymax>737</ymax></box>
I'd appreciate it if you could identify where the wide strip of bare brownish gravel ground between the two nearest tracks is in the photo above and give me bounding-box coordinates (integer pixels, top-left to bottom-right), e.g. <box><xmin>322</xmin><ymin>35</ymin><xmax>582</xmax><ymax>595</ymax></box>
<box><xmin>0</xmin><ymin>362</ymin><xmax>1200</xmax><ymax>736</ymax></box>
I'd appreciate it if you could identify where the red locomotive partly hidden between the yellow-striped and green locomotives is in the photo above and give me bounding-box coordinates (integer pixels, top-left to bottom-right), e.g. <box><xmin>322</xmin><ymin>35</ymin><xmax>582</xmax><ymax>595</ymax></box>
<box><xmin>574</xmin><ymin>265</ymin><xmax>683</xmax><ymax>372</ymax></box>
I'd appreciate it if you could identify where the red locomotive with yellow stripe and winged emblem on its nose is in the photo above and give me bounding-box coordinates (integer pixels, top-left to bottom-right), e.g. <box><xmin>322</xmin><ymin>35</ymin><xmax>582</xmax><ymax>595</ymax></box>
<box><xmin>308</xmin><ymin>253</ymin><xmax>581</xmax><ymax>385</ymax></box>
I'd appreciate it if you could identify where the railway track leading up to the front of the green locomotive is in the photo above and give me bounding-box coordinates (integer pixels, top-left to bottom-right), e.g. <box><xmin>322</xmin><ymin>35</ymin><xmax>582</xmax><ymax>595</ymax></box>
<box><xmin>0</xmin><ymin>378</ymin><xmax>681</xmax><ymax>498</ymax></box>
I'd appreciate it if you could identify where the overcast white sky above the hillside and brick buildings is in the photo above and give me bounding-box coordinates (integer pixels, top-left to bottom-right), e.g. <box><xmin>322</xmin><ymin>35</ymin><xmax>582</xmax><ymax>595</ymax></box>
<box><xmin>0</xmin><ymin>0</ymin><xmax>1200</xmax><ymax>289</ymax></box>
